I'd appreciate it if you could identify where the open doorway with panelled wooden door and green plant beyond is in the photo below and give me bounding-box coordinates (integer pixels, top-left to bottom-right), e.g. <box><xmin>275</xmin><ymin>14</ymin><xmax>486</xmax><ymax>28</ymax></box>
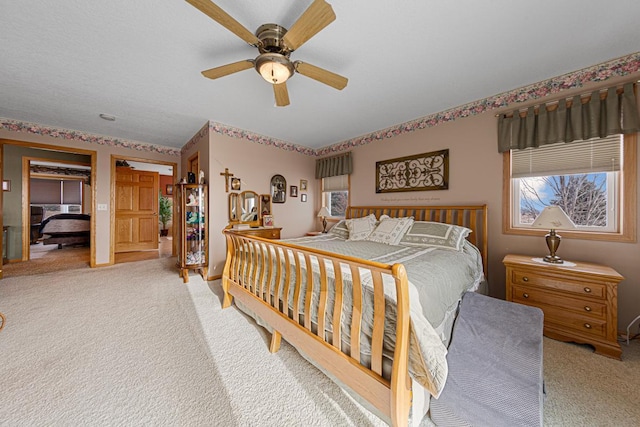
<box><xmin>111</xmin><ymin>156</ymin><xmax>178</xmax><ymax>264</ymax></box>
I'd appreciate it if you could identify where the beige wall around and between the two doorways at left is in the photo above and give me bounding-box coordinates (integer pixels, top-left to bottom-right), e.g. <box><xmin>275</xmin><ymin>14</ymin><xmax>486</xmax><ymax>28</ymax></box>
<box><xmin>0</xmin><ymin>129</ymin><xmax>179</xmax><ymax>266</ymax></box>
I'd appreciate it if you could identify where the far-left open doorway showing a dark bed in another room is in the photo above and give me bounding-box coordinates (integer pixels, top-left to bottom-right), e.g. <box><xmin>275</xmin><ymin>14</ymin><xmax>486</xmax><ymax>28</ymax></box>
<box><xmin>2</xmin><ymin>140</ymin><xmax>96</xmax><ymax>277</ymax></box>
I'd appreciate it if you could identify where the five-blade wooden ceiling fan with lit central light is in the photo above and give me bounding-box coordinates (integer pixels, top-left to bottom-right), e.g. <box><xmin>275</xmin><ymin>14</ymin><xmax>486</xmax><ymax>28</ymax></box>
<box><xmin>186</xmin><ymin>0</ymin><xmax>348</xmax><ymax>107</ymax></box>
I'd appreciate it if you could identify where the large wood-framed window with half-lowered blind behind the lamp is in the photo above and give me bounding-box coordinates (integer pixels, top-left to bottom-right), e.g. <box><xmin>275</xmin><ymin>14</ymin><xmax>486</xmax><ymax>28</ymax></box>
<box><xmin>503</xmin><ymin>135</ymin><xmax>636</xmax><ymax>241</ymax></box>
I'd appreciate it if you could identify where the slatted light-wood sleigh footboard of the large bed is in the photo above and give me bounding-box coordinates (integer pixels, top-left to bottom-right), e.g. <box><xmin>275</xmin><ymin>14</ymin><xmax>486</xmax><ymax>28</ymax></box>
<box><xmin>222</xmin><ymin>230</ymin><xmax>411</xmax><ymax>426</ymax></box>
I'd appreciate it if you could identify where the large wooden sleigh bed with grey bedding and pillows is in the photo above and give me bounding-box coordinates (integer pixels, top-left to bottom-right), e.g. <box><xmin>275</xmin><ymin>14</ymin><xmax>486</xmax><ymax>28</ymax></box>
<box><xmin>222</xmin><ymin>205</ymin><xmax>487</xmax><ymax>425</ymax></box>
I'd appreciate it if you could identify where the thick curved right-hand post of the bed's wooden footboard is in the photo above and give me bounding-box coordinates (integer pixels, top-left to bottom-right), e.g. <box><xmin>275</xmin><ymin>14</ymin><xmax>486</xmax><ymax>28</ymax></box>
<box><xmin>390</xmin><ymin>264</ymin><xmax>411</xmax><ymax>426</ymax></box>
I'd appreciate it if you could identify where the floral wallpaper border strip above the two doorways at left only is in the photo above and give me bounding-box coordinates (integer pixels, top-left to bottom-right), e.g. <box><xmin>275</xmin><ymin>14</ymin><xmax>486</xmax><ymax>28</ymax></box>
<box><xmin>0</xmin><ymin>118</ymin><xmax>180</xmax><ymax>156</ymax></box>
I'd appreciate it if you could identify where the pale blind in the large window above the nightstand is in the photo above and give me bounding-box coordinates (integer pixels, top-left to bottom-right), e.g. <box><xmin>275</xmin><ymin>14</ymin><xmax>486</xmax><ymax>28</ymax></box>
<box><xmin>511</xmin><ymin>135</ymin><xmax>622</xmax><ymax>178</ymax></box>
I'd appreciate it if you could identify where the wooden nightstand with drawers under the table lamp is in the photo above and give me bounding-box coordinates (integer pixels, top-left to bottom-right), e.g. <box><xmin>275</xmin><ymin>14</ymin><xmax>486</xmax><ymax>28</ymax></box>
<box><xmin>502</xmin><ymin>255</ymin><xmax>624</xmax><ymax>359</ymax></box>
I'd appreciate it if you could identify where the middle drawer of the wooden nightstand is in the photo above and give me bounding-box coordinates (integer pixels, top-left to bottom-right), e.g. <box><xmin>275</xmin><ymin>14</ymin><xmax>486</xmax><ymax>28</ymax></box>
<box><xmin>511</xmin><ymin>286</ymin><xmax>607</xmax><ymax>320</ymax></box>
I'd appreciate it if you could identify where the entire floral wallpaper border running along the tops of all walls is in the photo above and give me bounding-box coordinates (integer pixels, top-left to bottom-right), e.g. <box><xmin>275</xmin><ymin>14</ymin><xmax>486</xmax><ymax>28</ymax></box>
<box><xmin>0</xmin><ymin>52</ymin><xmax>640</xmax><ymax>157</ymax></box>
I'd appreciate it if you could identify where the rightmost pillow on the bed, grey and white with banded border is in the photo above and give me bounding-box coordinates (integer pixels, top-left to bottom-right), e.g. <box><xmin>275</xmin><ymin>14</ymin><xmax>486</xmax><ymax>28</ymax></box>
<box><xmin>400</xmin><ymin>221</ymin><xmax>471</xmax><ymax>251</ymax></box>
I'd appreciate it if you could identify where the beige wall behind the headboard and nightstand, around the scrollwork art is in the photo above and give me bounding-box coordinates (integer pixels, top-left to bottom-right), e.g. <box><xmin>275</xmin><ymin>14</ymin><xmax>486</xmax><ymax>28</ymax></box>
<box><xmin>351</xmin><ymin>85</ymin><xmax>640</xmax><ymax>330</ymax></box>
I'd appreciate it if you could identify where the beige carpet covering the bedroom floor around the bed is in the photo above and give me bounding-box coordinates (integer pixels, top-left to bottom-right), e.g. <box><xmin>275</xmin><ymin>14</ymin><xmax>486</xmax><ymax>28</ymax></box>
<box><xmin>0</xmin><ymin>258</ymin><xmax>640</xmax><ymax>426</ymax></box>
